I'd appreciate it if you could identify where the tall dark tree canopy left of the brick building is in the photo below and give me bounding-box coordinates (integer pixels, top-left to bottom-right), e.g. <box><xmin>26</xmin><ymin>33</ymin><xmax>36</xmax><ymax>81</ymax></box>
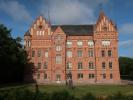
<box><xmin>0</xmin><ymin>25</ymin><xmax>27</xmax><ymax>83</ymax></box>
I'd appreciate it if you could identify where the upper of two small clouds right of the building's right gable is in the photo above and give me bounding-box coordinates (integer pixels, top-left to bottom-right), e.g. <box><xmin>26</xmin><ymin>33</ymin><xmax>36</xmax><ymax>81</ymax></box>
<box><xmin>119</xmin><ymin>23</ymin><xmax>133</xmax><ymax>34</ymax></box>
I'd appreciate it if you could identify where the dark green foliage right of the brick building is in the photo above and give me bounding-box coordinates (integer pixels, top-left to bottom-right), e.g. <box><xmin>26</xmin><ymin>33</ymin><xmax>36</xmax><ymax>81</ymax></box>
<box><xmin>119</xmin><ymin>57</ymin><xmax>133</xmax><ymax>80</ymax></box>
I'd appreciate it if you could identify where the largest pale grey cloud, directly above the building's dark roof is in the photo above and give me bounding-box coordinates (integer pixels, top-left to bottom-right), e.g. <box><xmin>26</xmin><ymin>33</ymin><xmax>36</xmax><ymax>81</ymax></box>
<box><xmin>40</xmin><ymin>0</ymin><xmax>108</xmax><ymax>24</ymax></box>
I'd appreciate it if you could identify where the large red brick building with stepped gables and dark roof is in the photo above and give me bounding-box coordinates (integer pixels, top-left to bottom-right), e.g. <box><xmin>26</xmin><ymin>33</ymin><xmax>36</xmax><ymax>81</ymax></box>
<box><xmin>24</xmin><ymin>12</ymin><xmax>120</xmax><ymax>84</ymax></box>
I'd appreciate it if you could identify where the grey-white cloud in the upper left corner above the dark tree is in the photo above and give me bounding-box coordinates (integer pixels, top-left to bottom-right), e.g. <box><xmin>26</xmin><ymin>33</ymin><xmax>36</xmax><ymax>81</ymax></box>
<box><xmin>0</xmin><ymin>0</ymin><xmax>32</xmax><ymax>22</ymax></box>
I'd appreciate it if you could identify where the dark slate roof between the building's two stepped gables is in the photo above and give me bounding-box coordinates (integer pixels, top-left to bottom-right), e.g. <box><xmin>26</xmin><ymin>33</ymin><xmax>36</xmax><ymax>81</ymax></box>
<box><xmin>51</xmin><ymin>25</ymin><xmax>94</xmax><ymax>36</ymax></box>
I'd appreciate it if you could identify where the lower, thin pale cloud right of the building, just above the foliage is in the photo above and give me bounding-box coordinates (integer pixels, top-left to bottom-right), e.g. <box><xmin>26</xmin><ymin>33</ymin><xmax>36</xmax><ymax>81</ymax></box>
<box><xmin>119</xmin><ymin>40</ymin><xmax>133</xmax><ymax>49</ymax></box>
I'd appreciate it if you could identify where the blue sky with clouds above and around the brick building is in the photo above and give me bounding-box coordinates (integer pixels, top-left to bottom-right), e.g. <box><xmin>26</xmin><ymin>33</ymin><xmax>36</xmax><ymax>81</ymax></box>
<box><xmin>0</xmin><ymin>0</ymin><xmax>133</xmax><ymax>57</ymax></box>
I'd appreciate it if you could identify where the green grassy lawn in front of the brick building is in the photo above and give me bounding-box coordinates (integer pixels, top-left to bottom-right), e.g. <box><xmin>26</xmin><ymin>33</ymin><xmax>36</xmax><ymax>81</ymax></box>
<box><xmin>0</xmin><ymin>84</ymin><xmax>133</xmax><ymax>97</ymax></box>
